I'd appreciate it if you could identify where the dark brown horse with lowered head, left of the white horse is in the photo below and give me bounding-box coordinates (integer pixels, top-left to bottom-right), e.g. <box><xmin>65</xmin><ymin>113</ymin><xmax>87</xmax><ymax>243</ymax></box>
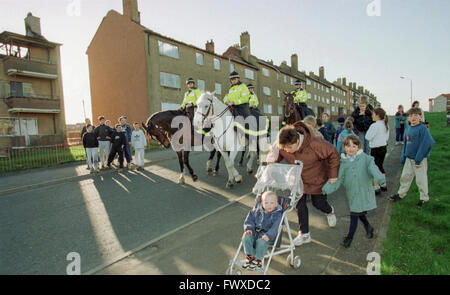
<box><xmin>142</xmin><ymin>110</ymin><xmax>221</xmax><ymax>183</ymax></box>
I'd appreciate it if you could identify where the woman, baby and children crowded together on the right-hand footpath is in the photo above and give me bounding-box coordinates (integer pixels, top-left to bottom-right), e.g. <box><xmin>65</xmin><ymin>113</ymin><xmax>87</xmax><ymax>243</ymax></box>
<box><xmin>243</xmin><ymin>97</ymin><xmax>434</xmax><ymax>268</ymax></box>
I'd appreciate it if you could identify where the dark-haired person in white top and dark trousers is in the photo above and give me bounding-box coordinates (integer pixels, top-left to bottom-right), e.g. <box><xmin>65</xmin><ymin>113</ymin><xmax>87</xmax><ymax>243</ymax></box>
<box><xmin>366</xmin><ymin>108</ymin><xmax>389</xmax><ymax>195</ymax></box>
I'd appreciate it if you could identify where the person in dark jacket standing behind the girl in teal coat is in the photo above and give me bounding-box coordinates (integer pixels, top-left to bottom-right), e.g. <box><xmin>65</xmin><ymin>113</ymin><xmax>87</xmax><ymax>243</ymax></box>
<box><xmin>352</xmin><ymin>96</ymin><xmax>373</xmax><ymax>155</ymax></box>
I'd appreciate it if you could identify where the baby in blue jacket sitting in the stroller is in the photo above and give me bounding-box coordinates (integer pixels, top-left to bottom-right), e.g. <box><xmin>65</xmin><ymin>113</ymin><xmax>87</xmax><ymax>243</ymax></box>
<box><xmin>243</xmin><ymin>191</ymin><xmax>283</xmax><ymax>269</ymax></box>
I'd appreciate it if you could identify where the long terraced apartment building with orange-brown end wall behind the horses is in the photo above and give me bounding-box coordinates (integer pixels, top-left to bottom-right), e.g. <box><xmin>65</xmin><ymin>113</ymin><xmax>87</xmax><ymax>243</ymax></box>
<box><xmin>86</xmin><ymin>0</ymin><xmax>380</xmax><ymax>126</ymax></box>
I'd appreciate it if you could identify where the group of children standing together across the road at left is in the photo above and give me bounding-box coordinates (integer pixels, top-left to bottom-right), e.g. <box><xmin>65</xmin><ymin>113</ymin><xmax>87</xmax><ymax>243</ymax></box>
<box><xmin>81</xmin><ymin>116</ymin><xmax>147</xmax><ymax>173</ymax></box>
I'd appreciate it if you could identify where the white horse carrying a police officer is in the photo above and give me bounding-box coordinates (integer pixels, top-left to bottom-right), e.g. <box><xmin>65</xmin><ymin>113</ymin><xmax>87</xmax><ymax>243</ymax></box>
<box><xmin>193</xmin><ymin>92</ymin><xmax>268</xmax><ymax>188</ymax></box>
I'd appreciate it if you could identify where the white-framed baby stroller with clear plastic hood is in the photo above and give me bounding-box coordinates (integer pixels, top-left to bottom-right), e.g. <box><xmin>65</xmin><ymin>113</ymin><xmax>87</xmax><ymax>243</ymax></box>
<box><xmin>226</xmin><ymin>161</ymin><xmax>303</xmax><ymax>275</ymax></box>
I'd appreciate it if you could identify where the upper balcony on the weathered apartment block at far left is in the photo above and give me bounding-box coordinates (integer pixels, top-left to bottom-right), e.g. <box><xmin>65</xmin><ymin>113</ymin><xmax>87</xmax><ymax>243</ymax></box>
<box><xmin>3</xmin><ymin>56</ymin><xmax>58</xmax><ymax>80</ymax></box>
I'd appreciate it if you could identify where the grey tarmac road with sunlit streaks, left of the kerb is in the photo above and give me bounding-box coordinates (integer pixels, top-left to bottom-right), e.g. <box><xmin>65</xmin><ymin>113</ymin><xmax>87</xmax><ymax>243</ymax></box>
<box><xmin>0</xmin><ymin>151</ymin><xmax>254</xmax><ymax>274</ymax></box>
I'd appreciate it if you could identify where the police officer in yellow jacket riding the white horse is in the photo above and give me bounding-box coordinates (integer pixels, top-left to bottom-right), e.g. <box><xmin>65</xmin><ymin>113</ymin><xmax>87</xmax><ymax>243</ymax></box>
<box><xmin>223</xmin><ymin>71</ymin><xmax>250</xmax><ymax>119</ymax></box>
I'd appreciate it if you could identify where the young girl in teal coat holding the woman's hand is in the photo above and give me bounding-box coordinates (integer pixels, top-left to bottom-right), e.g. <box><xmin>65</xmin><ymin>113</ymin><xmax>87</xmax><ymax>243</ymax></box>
<box><xmin>322</xmin><ymin>134</ymin><xmax>386</xmax><ymax>248</ymax></box>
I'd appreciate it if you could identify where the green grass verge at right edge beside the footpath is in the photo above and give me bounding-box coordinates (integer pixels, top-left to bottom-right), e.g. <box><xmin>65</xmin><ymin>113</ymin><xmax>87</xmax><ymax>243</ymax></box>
<box><xmin>381</xmin><ymin>112</ymin><xmax>450</xmax><ymax>275</ymax></box>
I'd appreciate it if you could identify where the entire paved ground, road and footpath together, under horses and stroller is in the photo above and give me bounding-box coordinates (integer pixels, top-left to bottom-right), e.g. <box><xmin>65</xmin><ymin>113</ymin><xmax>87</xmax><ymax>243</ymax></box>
<box><xmin>0</xmin><ymin>120</ymin><xmax>401</xmax><ymax>275</ymax></box>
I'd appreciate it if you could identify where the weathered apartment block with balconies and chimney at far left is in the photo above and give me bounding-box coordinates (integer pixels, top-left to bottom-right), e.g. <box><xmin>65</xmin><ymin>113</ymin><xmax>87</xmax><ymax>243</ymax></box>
<box><xmin>0</xmin><ymin>13</ymin><xmax>65</xmax><ymax>149</ymax></box>
